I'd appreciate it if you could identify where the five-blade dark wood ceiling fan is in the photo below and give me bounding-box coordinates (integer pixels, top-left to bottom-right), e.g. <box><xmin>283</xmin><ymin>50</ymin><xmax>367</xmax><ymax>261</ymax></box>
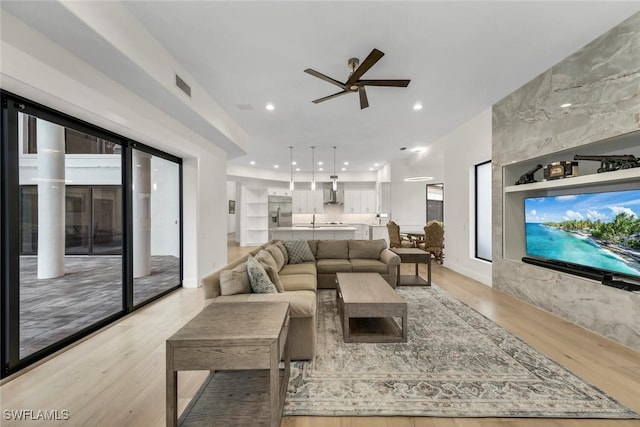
<box><xmin>304</xmin><ymin>49</ymin><xmax>411</xmax><ymax>109</ymax></box>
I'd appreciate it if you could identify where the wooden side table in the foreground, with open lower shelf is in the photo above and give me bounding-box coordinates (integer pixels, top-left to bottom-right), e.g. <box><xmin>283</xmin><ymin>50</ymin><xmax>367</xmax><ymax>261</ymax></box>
<box><xmin>166</xmin><ymin>302</ymin><xmax>290</xmax><ymax>427</ymax></box>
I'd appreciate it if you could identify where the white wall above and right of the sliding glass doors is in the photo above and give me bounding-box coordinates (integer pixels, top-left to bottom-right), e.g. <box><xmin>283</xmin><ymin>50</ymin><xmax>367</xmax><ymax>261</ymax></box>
<box><xmin>0</xmin><ymin>10</ymin><xmax>231</xmax><ymax>286</ymax></box>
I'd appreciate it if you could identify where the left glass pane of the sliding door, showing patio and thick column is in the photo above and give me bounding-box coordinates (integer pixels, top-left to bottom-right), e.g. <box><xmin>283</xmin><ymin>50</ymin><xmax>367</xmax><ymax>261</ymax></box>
<box><xmin>14</xmin><ymin>112</ymin><xmax>123</xmax><ymax>359</ymax></box>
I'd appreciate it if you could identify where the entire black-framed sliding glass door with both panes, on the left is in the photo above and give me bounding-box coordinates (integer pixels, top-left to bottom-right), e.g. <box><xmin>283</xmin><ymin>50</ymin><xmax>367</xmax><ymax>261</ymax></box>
<box><xmin>0</xmin><ymin>92</ymin><xmax>182</xmax><ymax>377</ymax></box>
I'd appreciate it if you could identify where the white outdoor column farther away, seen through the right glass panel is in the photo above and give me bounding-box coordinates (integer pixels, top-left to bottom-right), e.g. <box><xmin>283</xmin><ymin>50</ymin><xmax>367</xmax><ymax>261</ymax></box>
<box><xmin>132</xmin><ymin>150</ymin><xmax>151</xmax><ymax>277</ymax></box>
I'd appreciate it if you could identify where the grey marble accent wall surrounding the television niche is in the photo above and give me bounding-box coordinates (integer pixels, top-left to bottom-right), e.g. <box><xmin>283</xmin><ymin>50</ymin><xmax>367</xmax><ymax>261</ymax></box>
<box><xmin>492</xmin><ymin>13</ymin><xmax>640</xmax><ymax>351</ymax></box>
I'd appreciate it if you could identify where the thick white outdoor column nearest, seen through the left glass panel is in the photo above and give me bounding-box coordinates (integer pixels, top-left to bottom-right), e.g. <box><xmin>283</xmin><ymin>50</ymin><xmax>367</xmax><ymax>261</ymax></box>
<box><xmin>36</xmin><ymin>119</ymin><xmax>65</xmax><ymax>279</ymax></box>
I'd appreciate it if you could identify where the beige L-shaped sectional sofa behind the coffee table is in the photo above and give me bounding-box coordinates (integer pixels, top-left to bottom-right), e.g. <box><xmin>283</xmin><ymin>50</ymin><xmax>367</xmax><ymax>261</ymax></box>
<box><xmin>202</xmin><ymin>239</ymin><xmax>400</xmax><ymax>360</ymax></box>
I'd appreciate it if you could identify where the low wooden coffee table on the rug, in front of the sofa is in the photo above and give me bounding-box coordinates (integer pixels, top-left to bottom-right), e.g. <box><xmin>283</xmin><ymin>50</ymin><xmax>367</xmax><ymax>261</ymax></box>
<box><xmin>336</xmin><ymin>273</ymin><xmax>407</xmax><ymax>342</ymax></box>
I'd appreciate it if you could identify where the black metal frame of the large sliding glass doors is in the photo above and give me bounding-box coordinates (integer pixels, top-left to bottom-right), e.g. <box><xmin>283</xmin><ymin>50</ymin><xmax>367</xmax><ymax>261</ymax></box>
<box><xmin>0</xmin><ymin>90</ymin><xmax>184</xmax><ymax>378</ymax></box>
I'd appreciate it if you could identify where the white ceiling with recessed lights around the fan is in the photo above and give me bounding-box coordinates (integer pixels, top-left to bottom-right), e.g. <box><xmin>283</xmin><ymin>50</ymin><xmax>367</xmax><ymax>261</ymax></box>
<box><xmin>3</xmin><ymin>1</ymin><xmax>640</xmax><ymax>172</ymax></box>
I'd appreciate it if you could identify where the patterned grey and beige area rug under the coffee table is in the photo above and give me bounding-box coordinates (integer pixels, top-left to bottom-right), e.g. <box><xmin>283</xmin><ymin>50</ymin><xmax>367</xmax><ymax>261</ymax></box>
<box><xmin>284</xmin><ymin>286</ymin><xmax>639</xmax><ymax>418</ymax></box>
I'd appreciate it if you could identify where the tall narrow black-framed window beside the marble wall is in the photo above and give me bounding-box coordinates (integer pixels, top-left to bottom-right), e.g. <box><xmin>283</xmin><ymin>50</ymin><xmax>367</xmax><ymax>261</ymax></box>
<box><xmin>475</xmin><ymin>161</ymin><xmax>493</xmax><ymax>261</ymax></box>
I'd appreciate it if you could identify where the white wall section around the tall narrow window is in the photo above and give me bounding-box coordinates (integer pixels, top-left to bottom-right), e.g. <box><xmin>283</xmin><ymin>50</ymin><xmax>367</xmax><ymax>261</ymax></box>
<box><xmin>437</xmin><ymin>108</ymin><xmax>492</xmax><ymax>285</ymax></box>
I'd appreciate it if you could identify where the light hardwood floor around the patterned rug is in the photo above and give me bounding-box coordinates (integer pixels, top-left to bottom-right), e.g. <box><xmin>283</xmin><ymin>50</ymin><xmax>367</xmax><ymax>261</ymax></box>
<box><xmin>0</xmin><ymin>242</ymin><xmax>640</xmax><ymax>427</ymax></box>
